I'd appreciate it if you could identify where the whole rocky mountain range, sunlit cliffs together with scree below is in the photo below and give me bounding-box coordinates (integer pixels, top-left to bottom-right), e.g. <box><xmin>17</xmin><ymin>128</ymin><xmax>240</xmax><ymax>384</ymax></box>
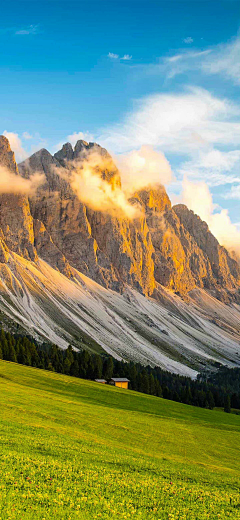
<box><xmin>0</xmin><ymin>136</ymin><xmax>240</xmax><ymax>377</ymax></box>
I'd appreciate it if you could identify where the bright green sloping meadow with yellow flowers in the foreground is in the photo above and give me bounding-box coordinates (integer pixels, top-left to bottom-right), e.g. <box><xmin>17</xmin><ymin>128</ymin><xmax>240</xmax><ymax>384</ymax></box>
<box><xmin>0</xmin><ymin>361</ymin><xmax>240</xmax><ymax>520</ymax></box>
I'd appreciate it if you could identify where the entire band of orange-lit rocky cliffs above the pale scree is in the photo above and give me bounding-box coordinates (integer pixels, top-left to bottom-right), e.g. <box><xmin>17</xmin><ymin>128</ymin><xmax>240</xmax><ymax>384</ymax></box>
<box><xmin>0</xmin><ymin>137</ymin><xmax>237</xmax><ymax>301</ymax></box>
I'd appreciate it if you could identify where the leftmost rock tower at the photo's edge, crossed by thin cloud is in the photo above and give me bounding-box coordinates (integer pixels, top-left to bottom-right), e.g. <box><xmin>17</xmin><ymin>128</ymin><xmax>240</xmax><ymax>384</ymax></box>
<box><xmin>0</xmin><ymin>136</ymin><xmax>37</xmax><ymax>261</ymax></box>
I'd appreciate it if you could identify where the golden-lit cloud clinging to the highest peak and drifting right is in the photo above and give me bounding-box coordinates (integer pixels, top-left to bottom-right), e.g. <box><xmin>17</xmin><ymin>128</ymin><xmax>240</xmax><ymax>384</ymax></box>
<box><xmin>58</xmin><ymin>146</ymin><xmax>172</xmax><ymax>219</ymax></box>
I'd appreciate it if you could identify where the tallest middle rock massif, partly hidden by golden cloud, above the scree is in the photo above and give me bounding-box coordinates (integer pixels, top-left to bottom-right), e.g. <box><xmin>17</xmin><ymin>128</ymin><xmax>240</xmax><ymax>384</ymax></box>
<box><xmin>19</xmin><ymin>141</ymin><xmax>155</xmax><ymax>295</ymax></box>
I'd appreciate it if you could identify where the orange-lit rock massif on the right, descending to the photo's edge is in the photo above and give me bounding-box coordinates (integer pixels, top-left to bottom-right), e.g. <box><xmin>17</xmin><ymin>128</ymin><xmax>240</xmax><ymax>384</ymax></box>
<box><xmin>131</xmin><ymin>186</ymin><xmax>240</xmax><ymax>301</ymax></box>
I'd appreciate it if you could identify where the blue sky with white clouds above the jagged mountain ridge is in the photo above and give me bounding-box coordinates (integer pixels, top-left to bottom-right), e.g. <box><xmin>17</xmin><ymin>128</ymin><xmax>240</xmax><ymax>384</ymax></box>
<box><xmin>0</xmin><ymin>0</ymin><xmax>240</xmax><ymax>236</ymax></box>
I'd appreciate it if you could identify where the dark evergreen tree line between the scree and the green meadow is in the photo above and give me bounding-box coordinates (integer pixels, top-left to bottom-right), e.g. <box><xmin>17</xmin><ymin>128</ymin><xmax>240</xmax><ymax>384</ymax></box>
<box><xmin>0</xmin><ymin>329</ymin><xmax>240</xmax><ymax>412</ymax></box>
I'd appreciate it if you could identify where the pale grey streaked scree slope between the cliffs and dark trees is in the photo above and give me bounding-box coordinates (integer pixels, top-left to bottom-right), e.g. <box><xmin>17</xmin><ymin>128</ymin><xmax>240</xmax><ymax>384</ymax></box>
<box><xmin>0</xmin><ymin>253</ymin><xmax>240</xmax><ymax>377</ymax></box>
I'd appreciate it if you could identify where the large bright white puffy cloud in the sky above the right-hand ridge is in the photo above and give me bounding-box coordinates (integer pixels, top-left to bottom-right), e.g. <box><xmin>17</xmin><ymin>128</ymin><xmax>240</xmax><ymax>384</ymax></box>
<box><xmin>99</xmin><ymin>87</ymin><xmax>240</xmax><ymax>154</ymax></box>
